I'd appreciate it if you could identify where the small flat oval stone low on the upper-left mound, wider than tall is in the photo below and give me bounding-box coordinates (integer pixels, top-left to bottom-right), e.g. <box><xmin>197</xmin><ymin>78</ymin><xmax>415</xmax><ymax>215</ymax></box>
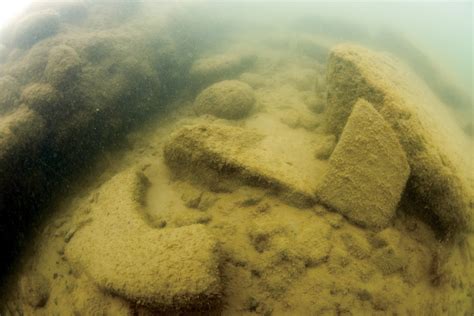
<box><xmin>21</xmin><ymin>83</ymin><xmax>59</xmax><ymax>114</ymax></box>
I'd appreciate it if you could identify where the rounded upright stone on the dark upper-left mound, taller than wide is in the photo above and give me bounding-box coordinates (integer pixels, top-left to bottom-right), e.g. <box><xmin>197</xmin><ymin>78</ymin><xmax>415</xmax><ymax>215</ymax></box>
<box><xmin>44</xmin><ymin>45</ymin><xmax>81</xmax><ymax>86</ymax></box>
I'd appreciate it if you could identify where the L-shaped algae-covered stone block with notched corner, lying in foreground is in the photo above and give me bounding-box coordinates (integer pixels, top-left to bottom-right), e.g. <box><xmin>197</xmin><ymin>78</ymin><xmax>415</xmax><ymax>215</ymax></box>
<box><xmin>66</xmin><ymin>170</ymin><xmax>221</xmax><ymax>310</ymax></box>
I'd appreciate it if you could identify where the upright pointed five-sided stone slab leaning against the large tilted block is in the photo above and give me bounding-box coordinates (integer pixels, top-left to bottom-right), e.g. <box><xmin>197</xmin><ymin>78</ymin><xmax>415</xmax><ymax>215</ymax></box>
<box><xmin>317</xmin><ymin>99</ymin><xmax>410</xmax><ymax>227</ymax></box>
